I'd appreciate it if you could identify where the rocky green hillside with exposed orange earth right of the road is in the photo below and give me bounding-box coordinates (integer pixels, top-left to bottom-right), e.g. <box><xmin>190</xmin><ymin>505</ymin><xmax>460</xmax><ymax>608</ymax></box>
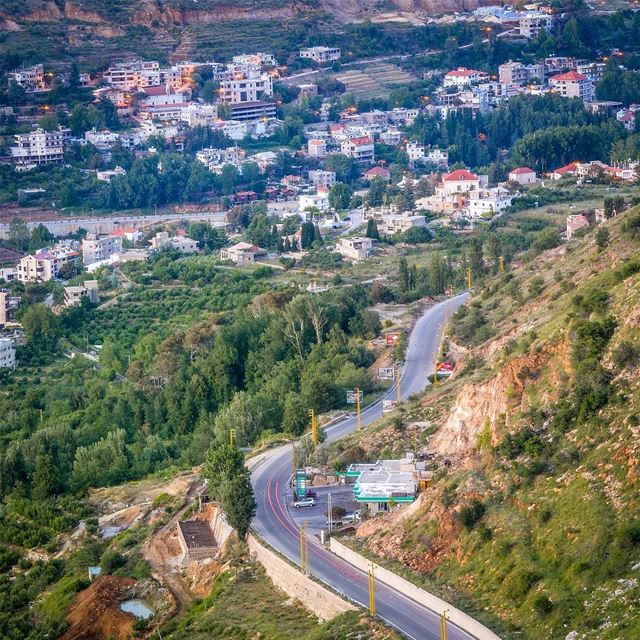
<box><xmin>336</xmin><ymin>202</ymin><xmax>640</xmax><ymax>640</ymax></box>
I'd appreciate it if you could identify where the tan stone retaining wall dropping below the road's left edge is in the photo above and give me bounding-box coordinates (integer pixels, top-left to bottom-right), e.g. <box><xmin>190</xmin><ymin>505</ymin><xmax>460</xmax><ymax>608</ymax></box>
<box><xmin>248</xmin><ymin>534</ymin><xmax>356</xmax><ymax>621</ymax></box>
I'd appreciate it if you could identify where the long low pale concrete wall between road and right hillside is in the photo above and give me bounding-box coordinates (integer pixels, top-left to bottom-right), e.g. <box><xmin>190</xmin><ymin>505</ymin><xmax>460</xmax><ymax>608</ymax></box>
<box><xmin>330</xmin><ymin>538</ymin><xmax>500</xmax><ymax>640</ymax></box>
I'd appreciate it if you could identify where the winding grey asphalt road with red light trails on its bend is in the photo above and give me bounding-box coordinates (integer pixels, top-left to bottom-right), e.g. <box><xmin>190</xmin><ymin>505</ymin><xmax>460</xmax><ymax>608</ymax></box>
<box><xmin>252</xmin><ymin>293</ymin><xmax>472</xmax><ymax>640</ymax></box>
